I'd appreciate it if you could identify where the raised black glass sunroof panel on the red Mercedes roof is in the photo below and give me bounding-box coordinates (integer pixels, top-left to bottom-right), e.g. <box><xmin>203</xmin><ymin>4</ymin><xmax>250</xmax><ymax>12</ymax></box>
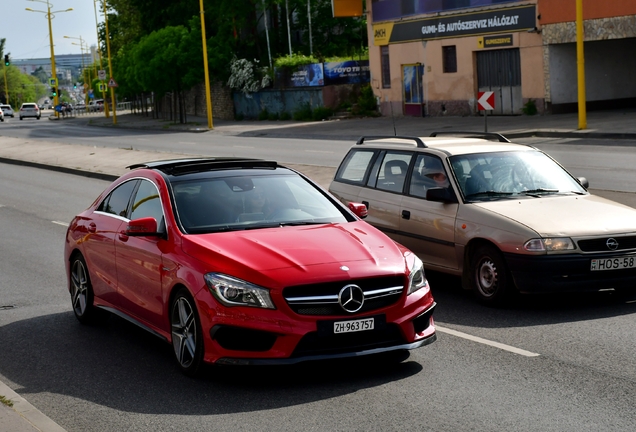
<box><xmin>128</xmin><ymin>157</ymin><xmax>278</xmax><ymax>175</ymax></box>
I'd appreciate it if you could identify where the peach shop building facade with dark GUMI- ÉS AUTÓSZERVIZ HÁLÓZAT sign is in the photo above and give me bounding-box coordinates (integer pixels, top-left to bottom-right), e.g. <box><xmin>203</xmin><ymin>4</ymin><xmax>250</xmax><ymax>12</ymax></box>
<box><xmin>366</xmin><ymin>0</ymin><xmax>636</xmax><ymax>116</ymax></box>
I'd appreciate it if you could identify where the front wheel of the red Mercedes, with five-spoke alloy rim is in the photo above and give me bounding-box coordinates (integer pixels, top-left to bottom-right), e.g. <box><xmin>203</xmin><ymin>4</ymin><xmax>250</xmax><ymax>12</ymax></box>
<box><xmin>170</xmin><ymin>288</ymin><xmax>203</xmax><ymax>376</ymax></box>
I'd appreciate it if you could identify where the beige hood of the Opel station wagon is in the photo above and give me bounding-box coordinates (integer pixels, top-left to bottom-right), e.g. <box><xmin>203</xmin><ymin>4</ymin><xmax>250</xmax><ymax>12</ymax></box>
<box><xmin>474</xmin><ymin>195</ymin><xmax>636</xmax><ymax>237</ymax></box>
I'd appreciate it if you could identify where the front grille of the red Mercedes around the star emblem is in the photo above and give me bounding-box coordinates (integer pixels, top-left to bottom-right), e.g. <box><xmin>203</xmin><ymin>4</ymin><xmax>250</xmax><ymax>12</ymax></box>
<box><xmin>283</xmin><ymin>276</ymin><xmax>405</xmax><ymax>316</ymax></box>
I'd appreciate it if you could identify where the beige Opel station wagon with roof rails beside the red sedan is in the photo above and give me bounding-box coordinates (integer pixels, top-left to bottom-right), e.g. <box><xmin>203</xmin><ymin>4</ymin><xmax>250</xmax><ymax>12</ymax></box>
<box><xmin>329</xmin><ymin>133</ymin><xmax>636</xmax><ymax>304</ymax></box>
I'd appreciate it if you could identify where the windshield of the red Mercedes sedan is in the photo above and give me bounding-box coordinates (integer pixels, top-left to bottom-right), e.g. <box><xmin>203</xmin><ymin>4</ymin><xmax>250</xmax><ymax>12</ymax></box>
<box><xmin>172</xmin><ymin>175</ymin><xmax>353</xmax><ymax>234</ymax></box>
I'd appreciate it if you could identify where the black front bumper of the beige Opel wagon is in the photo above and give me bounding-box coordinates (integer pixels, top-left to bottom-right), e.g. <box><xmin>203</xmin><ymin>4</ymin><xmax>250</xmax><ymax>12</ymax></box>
<box><xmin>504</xmin><ymin>253</ymin><xmax>636</xmax><ymax>293</ymax></box>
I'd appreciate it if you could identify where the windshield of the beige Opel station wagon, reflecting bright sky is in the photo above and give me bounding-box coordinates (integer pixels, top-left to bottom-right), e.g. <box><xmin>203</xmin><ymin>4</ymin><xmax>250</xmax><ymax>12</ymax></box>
<box><xmin>450</xmin><ymin>151</ymin><xmax>587</xmax><ymax>201</ymax></box>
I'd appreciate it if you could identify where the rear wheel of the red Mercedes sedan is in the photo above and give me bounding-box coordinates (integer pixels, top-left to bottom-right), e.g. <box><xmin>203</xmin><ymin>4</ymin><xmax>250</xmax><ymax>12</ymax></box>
<box><xmin>70</xmin><ymin>254</ymin><xmax>108</xmax><ymax>324</ymax></box>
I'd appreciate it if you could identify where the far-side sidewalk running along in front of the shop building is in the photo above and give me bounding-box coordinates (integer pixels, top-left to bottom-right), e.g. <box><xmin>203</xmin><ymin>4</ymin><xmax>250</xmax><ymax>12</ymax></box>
<box><xmin>71</xmin><ymin>107</ymin><xmax>636</xmax><ymax>141</ymax></box>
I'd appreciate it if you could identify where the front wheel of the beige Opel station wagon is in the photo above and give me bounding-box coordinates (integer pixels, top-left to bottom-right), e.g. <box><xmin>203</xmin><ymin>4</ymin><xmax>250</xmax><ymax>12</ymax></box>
<box><xmin>470</xmin><ymin>245</ymin><xmax>514</xmax><ymax>306</ymax></box>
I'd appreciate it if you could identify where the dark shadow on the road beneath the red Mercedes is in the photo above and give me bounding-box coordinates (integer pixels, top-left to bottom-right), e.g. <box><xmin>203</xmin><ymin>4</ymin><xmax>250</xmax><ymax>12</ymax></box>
<box><xmin>0</xmin><ymin>312</ymin><xmax>423</xmax><ymax>415</ymax></box>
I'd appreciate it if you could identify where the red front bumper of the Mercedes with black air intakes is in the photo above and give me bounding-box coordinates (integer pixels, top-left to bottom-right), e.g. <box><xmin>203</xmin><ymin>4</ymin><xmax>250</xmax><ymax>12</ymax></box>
<box><xmin>198</xmin><ymin>291</ymin><xmax>436</xmax><ymax>365</ymax></box>
